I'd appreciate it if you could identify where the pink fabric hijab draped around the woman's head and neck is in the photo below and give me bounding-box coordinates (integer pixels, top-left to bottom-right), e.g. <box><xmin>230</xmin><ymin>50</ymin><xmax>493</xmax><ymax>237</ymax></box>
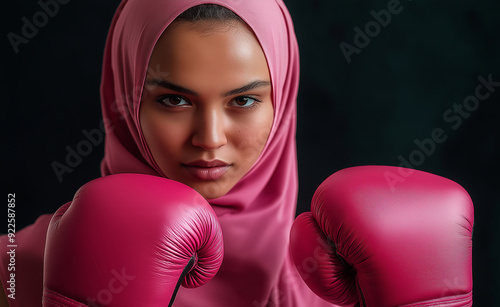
<box><xmin>97</xmin><ymin>0</ymin><xmax>331</xmax><ymax>306</ymax></box>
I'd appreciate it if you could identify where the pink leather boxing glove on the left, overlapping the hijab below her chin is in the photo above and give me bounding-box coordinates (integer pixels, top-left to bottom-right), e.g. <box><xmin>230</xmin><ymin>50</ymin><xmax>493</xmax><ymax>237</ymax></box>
<box><xmin>43</xmin><ymin>174</ymin><xmax>223</xmax><ymax>307</ymax></box>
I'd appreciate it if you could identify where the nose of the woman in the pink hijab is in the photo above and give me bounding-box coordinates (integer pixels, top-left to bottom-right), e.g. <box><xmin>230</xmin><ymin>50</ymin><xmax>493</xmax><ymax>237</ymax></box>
<box><xmin>192</xmin><ymin>108</ymin><xmax>227</xmax><ymax>150</ymax></box>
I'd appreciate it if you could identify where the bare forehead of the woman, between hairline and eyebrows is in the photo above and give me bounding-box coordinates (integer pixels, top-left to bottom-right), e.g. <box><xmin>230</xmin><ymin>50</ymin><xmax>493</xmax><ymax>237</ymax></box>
<box><xmin>149</xmin><ymin>21</ymin><xmax>270</xmax><ymax>92</ymax></box>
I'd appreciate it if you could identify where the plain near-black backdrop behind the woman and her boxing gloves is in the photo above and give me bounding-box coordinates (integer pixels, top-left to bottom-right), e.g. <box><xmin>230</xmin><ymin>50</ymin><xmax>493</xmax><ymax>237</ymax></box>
<box><xmin>0</xmin><ymin>0</ymin><xmax>500</xmax><ymax>306</ymax></box>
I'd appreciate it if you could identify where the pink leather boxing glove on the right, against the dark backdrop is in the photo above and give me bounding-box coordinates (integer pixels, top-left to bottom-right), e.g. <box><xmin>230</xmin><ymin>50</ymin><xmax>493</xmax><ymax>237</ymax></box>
<box><xmin>290</xmin><ymin>166</ymin><xmax>474</xmax><ymax>307</ymax></box>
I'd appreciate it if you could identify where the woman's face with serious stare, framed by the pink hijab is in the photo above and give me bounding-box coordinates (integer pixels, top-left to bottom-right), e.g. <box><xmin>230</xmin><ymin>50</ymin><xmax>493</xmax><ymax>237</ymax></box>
<box><xmin>140</xmin><ymin>21</ymin><xmax>273</xmax><ymax>199</ymax></box>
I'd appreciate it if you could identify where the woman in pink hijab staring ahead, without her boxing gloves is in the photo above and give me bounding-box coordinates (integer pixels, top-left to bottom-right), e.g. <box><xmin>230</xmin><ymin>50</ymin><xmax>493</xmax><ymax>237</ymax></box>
<box><xmin>1</xmin><ymin>0</ymin><xmax>331</xmax><ymax>306</ymax></box>
